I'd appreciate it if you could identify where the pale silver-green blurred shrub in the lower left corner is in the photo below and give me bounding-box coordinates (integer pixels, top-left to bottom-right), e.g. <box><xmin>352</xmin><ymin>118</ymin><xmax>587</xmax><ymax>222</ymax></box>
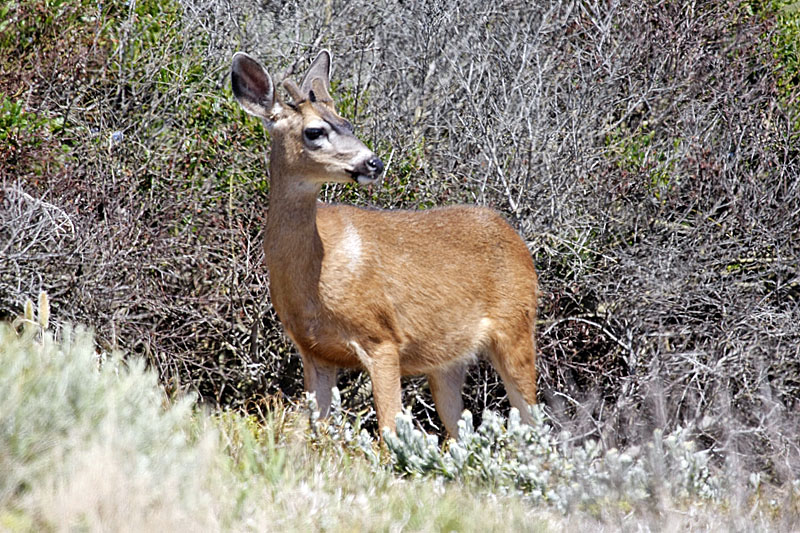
<box><xmin>0</xmin><ymin>320</ymin><xmax>216</xmax><ymax>527</ymax></box>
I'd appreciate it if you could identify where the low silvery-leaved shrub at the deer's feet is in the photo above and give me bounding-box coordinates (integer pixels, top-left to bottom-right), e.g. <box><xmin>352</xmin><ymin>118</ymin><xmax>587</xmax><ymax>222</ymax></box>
<box><xmin>311</xmin><ymin>393</ymin><xmax>723</xmax><ymax>512</ymax></box>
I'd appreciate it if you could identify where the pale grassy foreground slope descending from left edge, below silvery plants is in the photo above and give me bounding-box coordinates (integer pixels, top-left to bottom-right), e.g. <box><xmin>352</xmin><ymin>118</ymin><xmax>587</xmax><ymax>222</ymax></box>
<box><xmin>0</xmin><ymin>316</ymin><xmax>547</xmax><ymax>531</ymax></box>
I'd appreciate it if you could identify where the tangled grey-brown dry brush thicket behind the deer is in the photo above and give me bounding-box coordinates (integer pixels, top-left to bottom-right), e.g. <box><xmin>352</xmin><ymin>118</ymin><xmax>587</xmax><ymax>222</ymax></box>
<box><xmin>0</xmin><ymin>0</ymin><xmax>800</xmax><ymax>481</ymax></box>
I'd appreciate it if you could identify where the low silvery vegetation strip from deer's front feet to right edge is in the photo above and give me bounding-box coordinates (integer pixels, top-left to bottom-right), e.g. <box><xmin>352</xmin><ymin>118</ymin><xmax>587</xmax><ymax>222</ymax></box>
<box><xmin>305</xmin><ymin>389</ymin><xmax>800</xmax><ymax>531</ymax></box>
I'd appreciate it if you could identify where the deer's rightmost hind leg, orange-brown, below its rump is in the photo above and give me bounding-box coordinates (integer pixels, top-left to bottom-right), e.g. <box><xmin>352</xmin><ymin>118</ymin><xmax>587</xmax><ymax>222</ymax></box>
<box><xmin>489</xmin><ymin>331</ymin><xmax>536</xmax><ymax>424</ymax></box>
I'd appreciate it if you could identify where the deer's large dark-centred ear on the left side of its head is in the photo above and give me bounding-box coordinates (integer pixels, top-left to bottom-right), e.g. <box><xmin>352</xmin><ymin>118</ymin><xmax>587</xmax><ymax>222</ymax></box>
<box><xmin>231</xmin><ymin>52</ymin><xmax>280</xmax><ymax>125</ymax></box>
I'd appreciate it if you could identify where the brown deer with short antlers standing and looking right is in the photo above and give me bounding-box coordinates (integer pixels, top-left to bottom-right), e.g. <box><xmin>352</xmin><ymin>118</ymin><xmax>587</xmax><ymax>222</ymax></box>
<box><xmin>231</xmin><ymin>50</ymin><xmax>537</xmax><ymax>436</ymax></box>
